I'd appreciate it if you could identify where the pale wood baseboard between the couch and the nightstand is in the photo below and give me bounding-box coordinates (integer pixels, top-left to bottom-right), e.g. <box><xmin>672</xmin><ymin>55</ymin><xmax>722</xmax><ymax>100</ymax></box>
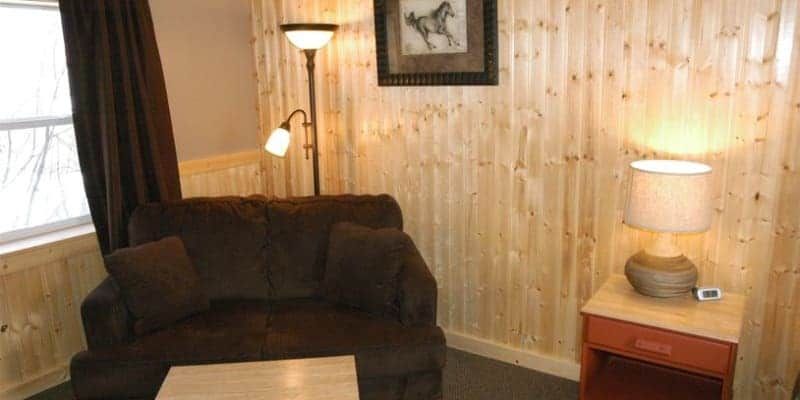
<box><xmin>445</xmin><ymin>331</ymin><xmax>581</xmax><ymax>382</ymax></box>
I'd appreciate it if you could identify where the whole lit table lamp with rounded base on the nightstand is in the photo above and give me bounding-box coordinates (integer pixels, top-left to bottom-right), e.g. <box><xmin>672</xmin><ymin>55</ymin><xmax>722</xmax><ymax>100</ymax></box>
<box><xmin>624</xmin><ymin>160</ymin><xmax>712</xmax><ymax>297</ymax></box>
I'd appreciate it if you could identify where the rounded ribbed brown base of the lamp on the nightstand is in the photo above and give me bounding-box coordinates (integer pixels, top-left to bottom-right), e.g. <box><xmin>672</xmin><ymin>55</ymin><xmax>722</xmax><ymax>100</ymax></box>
<box><xmin>625</xmin><ymin>251</ymin><xmax>697</xmax><ymax>297</ymax></box>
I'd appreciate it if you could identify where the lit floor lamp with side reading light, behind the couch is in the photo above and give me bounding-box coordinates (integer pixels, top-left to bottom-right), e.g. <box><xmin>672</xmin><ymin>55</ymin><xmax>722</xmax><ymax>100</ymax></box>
<box><xmin>264</xmin><ymin>24</ymin><xmax>338</xmax><ymax>196</ymax></box>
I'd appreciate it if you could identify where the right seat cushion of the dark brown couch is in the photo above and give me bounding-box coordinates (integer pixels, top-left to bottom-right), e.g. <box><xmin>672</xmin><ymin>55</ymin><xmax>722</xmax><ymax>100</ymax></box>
<box><xmin>264</xmin><ymin>300</ymin><xmax>445</xmax><ymax>379</ymax></box>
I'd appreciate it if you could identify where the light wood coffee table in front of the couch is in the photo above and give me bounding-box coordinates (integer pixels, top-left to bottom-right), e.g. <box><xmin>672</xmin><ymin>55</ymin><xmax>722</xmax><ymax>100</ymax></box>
<box><xmin>156</xmin><ymin>356</ymin><xmax>358</xmax><ymax>400</ymax></box>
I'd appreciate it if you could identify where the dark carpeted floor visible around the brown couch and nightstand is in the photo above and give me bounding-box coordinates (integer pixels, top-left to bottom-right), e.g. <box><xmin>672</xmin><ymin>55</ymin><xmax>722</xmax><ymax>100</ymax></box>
<box><xmin>30</xmin><ymin>349</ymin><xmax>578</xmax><ymax>400</ymax></box>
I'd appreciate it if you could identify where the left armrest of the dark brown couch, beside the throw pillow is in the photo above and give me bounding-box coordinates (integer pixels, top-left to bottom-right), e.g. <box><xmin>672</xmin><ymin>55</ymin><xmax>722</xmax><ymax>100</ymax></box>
<box><xmin>81</xmin><ymin>277</ymin><xmax>131</xmax><ymax>350</ymax></box>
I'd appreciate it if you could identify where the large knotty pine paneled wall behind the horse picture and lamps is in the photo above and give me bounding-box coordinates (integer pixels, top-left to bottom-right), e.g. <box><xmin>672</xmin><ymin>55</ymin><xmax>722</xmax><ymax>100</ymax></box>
<box><xmin>253</xmin><ymin>0</ymin><xmax>800</xmax><ymax>399</ymax></box>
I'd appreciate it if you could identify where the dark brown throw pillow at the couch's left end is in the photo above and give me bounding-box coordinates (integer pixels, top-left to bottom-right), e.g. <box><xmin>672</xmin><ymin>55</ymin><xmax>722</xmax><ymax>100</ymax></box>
<box><xmin>105</xmin><ymin>236</ymin><xmax>209</xmax><ymax>335</ymax></box>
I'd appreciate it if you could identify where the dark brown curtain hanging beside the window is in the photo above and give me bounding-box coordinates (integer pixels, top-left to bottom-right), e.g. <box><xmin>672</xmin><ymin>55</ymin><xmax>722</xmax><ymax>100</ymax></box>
<box><xmin>59</xmin><ymin>0</ymin><xmax>181</xmax><ymax>254</ymax></box>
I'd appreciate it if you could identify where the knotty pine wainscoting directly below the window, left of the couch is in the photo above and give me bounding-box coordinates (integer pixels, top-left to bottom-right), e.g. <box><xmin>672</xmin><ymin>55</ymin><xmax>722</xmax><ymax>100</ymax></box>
<box><xmin>0</xmin><ymin>233</ymin><xmax>106</xmax><ymax>400</ymax></box>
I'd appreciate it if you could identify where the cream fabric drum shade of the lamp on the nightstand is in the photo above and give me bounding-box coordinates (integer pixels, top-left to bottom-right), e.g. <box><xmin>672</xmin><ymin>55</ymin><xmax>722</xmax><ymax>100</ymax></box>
<box><xmin>625</xmin><ymin>160</ymin><xmax>713</xmax><ymax>233</ymax></box>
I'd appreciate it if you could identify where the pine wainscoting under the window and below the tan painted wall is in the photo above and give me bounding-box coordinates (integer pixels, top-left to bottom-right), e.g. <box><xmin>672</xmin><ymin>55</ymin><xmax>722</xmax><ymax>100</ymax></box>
<box><xmin>0</xmin><ymin>151</ymin><xmax>263</xmax><ymax>400</ymax></box>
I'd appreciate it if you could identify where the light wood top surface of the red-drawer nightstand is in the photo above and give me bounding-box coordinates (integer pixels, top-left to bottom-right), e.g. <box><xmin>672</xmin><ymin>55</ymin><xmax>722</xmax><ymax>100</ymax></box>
<box><xmin>581</xmin><ymin>275</ymin><xmax>744</xmax><ymax>343</ymax></box>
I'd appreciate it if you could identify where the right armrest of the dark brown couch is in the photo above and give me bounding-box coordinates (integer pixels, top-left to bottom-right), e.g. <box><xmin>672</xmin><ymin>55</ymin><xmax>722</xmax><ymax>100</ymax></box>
<box><xmin>400</xmin><ymin>240</ymin><xmax>437</xmax><ymax>326</ymax></box>
